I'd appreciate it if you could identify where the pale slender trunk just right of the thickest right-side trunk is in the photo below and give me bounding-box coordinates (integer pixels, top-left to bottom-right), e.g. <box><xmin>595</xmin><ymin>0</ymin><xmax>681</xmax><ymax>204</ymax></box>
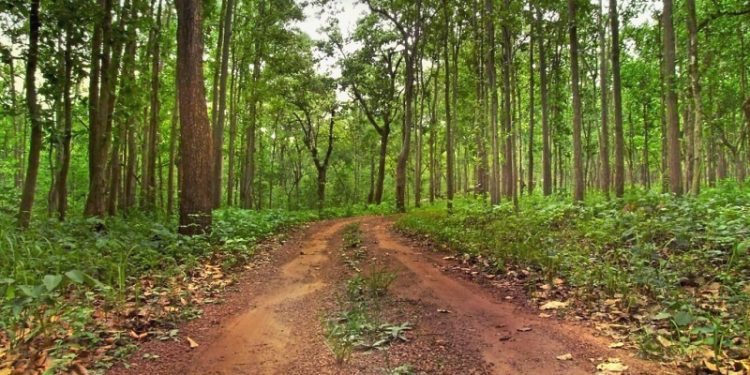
<box><xmin>685</xmin><ymin>0</ymin><xmax>703</xmax><ymax>195</ymax></box>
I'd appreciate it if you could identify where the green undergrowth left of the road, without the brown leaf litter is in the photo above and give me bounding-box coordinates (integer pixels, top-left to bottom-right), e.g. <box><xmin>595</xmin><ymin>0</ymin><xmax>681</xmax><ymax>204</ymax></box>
<box><xmin>0</xmin><ymin>210</ymin><xmax>314</xmax><ymax>354</ymax></box>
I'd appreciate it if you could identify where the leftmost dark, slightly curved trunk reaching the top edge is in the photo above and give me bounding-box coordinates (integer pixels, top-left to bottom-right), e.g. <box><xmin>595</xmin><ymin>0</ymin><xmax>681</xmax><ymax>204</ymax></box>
<box><xmin>17</xmin><ymin>0</ymin><xmax>42</xmax><ymax>228</ymax></box>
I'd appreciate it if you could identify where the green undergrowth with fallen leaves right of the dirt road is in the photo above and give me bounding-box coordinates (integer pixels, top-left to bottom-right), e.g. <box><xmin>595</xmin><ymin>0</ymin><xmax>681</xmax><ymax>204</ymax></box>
<box><xmin>397</xmin><ymin>184</ymin><xmax>750</xmax><ymax>373</ymax></box>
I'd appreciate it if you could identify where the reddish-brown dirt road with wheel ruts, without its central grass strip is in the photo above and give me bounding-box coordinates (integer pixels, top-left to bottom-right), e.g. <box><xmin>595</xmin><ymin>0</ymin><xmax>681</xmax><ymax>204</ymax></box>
<box><xmin>109</xmin><ymin>216</ymin><xmax>674</xmax><ymax>375</ymax></box>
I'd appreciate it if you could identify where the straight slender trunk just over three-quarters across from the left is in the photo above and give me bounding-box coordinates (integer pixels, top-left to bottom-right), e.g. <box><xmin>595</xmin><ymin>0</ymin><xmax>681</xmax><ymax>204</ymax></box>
<box><xmin>568</xmin><ymin>0</ymin><xmax>584</xmax><ymax>201</ymax></box>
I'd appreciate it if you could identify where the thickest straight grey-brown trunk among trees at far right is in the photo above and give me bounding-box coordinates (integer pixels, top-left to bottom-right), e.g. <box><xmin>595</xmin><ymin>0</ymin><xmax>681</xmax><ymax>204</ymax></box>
<box><xmin>662</xmin><ymin>0</ymin><xmax>682</xmax><ymax>196</ymax></box>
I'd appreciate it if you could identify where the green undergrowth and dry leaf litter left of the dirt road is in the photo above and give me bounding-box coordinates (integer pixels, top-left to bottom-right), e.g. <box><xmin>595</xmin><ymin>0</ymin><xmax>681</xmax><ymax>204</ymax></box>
<box><xmin>0</xmin><ymin>209</ymin><xmax>317</xmax><ymax>371</ymax></box>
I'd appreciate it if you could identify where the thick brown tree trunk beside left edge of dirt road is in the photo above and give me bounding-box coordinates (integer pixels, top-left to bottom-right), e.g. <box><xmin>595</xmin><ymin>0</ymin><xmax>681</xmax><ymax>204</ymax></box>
<box><xmin>175</xmin><ymin>0</ymin><xmax>213</xmax><ymax>235</ymax></box>
